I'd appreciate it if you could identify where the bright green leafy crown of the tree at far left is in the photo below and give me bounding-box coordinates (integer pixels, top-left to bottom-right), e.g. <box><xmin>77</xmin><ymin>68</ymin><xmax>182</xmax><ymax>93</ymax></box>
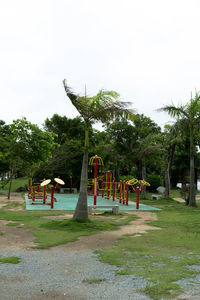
<box><xmin>0</xmin><ymin>118</ymin><xmax>55</xmax><ymax>192</ymax></box>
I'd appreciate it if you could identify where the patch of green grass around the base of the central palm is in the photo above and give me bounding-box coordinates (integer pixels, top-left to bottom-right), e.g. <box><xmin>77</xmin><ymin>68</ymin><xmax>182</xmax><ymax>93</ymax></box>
<box><xmin>0</xmin><ymin>208</ymin><xmax>137</xmax><ymax>249</ymax></box>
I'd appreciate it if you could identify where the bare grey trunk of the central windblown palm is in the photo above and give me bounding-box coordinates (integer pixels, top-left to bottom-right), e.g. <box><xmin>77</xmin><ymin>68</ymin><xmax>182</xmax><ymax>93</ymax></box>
<box><xmin>73</xmin><ymin>124</ymin><xmax>89</xmax><ymax>220</ymax></box>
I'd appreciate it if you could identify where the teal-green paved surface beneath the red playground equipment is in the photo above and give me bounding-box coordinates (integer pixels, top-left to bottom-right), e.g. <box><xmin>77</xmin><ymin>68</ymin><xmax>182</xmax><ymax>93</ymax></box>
<box><xmin>25</xmin><ymin>194</ymin><xmax>159</xmax><ymax>211</ymax></box>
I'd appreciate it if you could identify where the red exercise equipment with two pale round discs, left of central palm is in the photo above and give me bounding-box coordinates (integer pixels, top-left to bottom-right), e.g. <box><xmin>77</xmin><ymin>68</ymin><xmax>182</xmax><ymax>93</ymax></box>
<box><xmin>28</xmin><ymin>178</ymin><xmax>65</xmax><ymax>208</ymax></box>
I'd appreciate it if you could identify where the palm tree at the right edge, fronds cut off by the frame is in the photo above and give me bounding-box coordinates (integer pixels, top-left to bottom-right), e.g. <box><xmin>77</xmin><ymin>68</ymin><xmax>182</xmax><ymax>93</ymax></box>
<box><xmin>159</xmin><ymin>92</ymin><xmax>200</xmax><ymax>206</ymax></box>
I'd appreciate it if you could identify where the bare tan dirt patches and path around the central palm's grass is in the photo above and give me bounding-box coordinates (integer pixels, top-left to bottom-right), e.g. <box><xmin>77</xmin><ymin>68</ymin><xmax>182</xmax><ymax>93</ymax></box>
<box><xmin>0</xmin><ymin>196</ymin><xmax>159</xmax><ymax>251</ymax></box>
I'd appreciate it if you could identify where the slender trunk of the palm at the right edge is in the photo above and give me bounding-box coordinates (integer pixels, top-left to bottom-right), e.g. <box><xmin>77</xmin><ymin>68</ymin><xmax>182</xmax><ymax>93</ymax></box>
<box><xmin>189</xmin><ymin>125</ymin><xmax>197</xmax><ymax>207</ymax></box>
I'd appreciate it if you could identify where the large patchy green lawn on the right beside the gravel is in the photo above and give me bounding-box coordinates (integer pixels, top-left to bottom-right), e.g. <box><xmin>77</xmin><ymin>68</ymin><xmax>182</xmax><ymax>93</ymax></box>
<box><xmin>96</xmin><ymin>199</ymin><xmax>200</xmax><ymax>300</ymax></box>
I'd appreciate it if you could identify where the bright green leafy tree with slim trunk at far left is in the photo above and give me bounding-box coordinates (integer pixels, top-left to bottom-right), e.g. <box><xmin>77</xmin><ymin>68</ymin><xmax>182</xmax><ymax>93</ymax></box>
<box><xmin>8</xmin><ymin>118</ymin><xmax>54</xmax><ymax>199</ymax></box>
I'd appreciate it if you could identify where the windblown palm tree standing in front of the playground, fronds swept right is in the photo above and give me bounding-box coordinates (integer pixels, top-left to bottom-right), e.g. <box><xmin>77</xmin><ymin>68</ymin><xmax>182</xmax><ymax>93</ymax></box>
<box><xmin>63</xmin><ymin>79</ymin><xmax>133</xmax><ymax>220</ymax></box>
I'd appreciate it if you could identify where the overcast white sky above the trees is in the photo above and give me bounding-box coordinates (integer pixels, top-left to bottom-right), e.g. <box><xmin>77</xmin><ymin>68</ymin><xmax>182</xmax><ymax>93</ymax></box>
<box><xmin>0</xmin><ymin>0</ymin><xmax>200</xmax><ymax>130</ymax></box>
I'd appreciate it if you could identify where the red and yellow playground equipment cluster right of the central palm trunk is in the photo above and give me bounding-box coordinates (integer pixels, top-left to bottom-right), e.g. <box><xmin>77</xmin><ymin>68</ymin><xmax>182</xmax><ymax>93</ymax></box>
<box><xmin>88</xmin><ymin>155</ymin><xmax>150</xmax><ymax>209</ymax></box>
